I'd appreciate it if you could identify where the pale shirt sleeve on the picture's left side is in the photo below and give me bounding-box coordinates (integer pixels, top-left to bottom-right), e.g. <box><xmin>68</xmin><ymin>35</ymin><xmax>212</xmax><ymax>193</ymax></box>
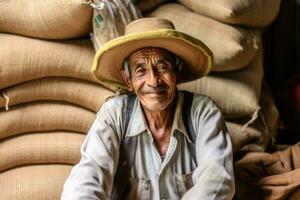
<box><xmin>61</xmin><ymin>97</ymin><xmax>122</xmax><ymax>200</ymax></box>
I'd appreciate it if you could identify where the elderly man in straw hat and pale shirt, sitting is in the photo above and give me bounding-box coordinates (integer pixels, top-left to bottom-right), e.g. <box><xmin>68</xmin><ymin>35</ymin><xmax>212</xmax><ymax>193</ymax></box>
<box><xmin>62</xmin><ymin>18</ymin><xmax>234</xmax><ymax>200</ymax></box>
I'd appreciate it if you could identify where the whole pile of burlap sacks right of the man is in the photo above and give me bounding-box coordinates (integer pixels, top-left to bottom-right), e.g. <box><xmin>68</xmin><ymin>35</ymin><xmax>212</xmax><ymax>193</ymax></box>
<box><xmin>148</xmin><ymin>0</ymin><xmax>280</xmax><ymax>152</ymax></box>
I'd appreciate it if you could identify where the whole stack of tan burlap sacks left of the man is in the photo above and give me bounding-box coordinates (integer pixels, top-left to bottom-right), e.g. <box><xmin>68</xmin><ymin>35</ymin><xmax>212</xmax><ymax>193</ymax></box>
<box><xmin>0</xmin><ymin>0</ymin><xmax>114</xmax><ymax>200</ymax></box>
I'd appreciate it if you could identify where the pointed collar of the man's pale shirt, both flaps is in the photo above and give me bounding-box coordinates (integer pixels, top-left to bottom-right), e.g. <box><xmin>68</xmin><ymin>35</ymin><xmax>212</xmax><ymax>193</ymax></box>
<box><xmin>126</xmin><ymin>91</ymin><xmax>191</xmax><ymax>142</ymax></box>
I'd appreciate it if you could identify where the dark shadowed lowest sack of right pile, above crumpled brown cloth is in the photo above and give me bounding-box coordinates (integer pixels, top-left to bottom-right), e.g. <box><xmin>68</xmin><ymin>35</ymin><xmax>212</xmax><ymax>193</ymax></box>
<box><xmin>226</xmin><ymin>82</ymin><xmax>279</xmax><ymax>152</ymax></box>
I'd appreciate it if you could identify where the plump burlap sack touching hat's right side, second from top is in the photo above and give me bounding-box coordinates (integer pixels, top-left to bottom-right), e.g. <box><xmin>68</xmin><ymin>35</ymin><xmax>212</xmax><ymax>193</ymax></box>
<box><xmin>150</xmin><ymin>3</ymin><xmax>259</xmax><ymax>71</ymax></box>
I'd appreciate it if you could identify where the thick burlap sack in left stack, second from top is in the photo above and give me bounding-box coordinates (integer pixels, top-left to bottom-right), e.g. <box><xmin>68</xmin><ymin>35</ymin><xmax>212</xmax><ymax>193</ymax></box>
<box><xmin>0</xmin><ymin>33</ymin><xmax>116</xmax><ymax>89</ymax></box>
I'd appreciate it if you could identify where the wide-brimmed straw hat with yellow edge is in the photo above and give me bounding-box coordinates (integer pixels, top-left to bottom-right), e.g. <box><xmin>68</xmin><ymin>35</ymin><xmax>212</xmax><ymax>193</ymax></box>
<box><xmin>92</xmin><ymin>18</ymin><xmax>213</xmax><ymax>90</ymax></box>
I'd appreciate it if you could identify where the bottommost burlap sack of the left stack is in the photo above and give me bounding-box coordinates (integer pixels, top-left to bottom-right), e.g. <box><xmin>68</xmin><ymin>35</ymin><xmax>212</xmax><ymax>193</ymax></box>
<box><xmin>0</xmin><ymin>165</ymin><xmax>72</xmax><ymax>200</ymax></box>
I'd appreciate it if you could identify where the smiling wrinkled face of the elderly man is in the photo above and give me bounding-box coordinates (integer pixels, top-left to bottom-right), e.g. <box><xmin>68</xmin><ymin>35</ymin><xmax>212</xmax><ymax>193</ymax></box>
<box><xmin>129</xmin><ymin>48</ymin><xmax>177</xmax><ymax>111</ymax></box>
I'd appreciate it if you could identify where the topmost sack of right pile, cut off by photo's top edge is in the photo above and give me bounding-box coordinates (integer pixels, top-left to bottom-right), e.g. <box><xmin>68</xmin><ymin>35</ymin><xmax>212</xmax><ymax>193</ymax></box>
<box><xmin>177</xmin><ymin>0</ymin><xmax>280</xmax><ymax>27</ymax></box>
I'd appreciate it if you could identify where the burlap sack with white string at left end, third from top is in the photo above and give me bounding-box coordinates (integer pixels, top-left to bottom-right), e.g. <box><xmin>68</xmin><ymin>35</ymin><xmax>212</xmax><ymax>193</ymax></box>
<box><xmin>0</xmin><ymin>78</ymin><xmax>114</xmax><ymax>112</ymax></box>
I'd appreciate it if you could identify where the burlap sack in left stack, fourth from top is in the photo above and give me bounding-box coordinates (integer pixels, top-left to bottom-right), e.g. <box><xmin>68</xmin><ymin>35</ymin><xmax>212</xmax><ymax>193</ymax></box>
<box><xmin>0</xmin><ymin>102</ymin><xmax>95</xmax><ymax>139</ymax></box>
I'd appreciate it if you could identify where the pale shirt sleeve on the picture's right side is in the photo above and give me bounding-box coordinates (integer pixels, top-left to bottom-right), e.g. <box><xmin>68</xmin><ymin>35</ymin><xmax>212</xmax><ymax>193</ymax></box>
<box><xmin>183</xmin><ymin>98</ymin><xmax>235</xmax><ymax>200</ymax></box>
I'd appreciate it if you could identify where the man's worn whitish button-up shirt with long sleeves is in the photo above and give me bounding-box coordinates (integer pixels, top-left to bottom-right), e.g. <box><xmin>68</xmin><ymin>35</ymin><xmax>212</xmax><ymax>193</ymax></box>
<box><xmin>62</xmin><ymin>91</ymin><xmax>234</xmax><ymax>200</ymax></box>
